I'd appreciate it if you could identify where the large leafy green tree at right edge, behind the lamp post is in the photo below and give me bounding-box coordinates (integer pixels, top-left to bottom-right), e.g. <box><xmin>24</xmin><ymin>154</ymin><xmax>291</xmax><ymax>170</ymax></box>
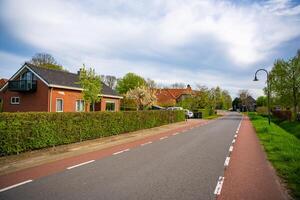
<box><xmin>269</xmin><ymin>50</ymin><xmax>300</xmax><ymax>119</ymax></box>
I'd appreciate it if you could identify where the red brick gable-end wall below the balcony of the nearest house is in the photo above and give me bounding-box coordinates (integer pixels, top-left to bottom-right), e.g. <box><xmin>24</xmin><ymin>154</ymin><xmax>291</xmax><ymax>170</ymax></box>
<box><xmin>0</xmin><ymin>80</ymin><xmax>48</xmax><ymax>112</ymax></box>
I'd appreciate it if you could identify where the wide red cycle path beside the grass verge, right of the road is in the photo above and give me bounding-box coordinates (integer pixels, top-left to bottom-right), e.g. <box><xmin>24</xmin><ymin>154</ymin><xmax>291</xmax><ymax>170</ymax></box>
<box><xmin>217</xmin><ymin>117</ymin><xmax>288</xmax><ymax>200</ymax></box>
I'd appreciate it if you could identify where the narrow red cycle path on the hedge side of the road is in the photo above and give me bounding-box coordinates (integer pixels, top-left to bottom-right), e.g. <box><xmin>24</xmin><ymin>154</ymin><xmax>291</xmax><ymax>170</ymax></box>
<box><xmin>0</xmin><ymin>120</ymin><xmax>214</xmax><ymax>189</ymax></box>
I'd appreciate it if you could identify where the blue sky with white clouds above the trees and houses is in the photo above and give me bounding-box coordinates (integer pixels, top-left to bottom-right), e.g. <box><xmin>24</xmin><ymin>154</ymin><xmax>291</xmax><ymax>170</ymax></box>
<box><xmin>0</xmin><ymin>0</ymin><xmax>300</xmax><ymax>97</ymax></box>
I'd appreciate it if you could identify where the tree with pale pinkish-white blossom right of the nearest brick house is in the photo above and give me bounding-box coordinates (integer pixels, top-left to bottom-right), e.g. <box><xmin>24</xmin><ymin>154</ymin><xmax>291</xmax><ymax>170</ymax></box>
<box><xmin>126</xmin><ymin>85</ymin><xmax>156</xmax><ymax>110</ymax></box>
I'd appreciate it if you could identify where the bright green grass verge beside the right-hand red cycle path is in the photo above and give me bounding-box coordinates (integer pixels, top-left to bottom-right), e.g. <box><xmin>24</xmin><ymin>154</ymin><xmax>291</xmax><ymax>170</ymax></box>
<box><xmin>249</xmin><ymin>113</ymin><xmax>300</xmax><ymax>199</ymax></box>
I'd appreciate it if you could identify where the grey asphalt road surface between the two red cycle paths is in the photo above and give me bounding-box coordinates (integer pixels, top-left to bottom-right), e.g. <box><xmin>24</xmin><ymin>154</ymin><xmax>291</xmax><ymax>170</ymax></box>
<box><xmin>0</xmin><ymin>113</ymin><xmax>241</xmax><ymax>200</ymax></box>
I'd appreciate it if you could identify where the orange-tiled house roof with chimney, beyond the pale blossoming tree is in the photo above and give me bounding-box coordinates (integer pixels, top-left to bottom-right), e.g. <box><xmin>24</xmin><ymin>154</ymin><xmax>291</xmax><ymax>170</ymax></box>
<box><xmin>155</xmin><ymin>85</ymin><xmax>193</xmax><ymax>106</ymax></box>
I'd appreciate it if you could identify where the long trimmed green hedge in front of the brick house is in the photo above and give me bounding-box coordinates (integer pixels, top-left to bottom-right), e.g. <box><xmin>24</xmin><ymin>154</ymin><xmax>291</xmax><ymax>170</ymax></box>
<box><xmin>0</xmin><ymin>111</ymin><xmax>185</xmax><ymax>156</ymax></box>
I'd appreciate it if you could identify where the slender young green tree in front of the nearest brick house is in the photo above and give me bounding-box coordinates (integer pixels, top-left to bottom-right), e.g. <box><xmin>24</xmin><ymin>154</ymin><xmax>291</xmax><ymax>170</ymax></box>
<box><xmin>79</xmin><ymin>65</ymin><xmax>102</xmax><ymax>111</ymax></box>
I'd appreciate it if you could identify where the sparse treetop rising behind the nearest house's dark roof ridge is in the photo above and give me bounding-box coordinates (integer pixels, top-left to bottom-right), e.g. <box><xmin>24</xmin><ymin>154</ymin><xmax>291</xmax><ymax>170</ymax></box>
<box><xmin>29</xmin><ymin>53</ymin><xmax>63</xmax><ymax>70</ymax></box>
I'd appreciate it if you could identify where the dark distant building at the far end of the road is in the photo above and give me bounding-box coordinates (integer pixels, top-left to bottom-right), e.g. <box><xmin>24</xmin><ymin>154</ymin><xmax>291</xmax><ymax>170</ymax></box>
<box><xmin>232</xmin><ymin>96</ymin><xmax>256</xmax><ymax>112</ymax></box>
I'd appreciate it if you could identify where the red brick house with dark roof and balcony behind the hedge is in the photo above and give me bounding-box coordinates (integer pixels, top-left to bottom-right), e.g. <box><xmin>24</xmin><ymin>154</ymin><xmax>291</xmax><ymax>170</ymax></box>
<box><xmin>0</xmin><ymin>63</ymin><xmax>122</xmax><ymax>112</ymax></box>
